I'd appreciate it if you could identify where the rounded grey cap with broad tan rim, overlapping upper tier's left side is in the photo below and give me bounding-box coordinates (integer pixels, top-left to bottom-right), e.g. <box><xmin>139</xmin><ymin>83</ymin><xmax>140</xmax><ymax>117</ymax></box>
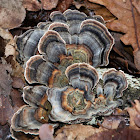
<box><xmin>38</xmin><ymin>31</ymin><xmax>66</xmax><ymax>63</ymax></box>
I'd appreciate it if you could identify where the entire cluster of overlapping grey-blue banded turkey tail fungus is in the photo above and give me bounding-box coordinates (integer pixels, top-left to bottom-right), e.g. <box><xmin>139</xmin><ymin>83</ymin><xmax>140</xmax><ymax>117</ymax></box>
<box><xmin>11</xmin><ymin>9</ymin><xmax>127</xmax><ymax>134</ymax></box>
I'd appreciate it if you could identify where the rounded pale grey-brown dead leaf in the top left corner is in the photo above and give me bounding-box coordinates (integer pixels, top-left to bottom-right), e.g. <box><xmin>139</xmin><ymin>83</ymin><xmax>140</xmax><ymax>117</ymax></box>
<box><xmin>0</xmin><ymin>0</ymin><xmax>26</xmax><ymax>29</ymax></box>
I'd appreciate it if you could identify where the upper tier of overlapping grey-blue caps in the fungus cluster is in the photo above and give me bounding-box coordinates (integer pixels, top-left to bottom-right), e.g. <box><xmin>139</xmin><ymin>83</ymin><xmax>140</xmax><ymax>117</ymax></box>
<box><xmin>17</xmin><ymin>9</ymin><xmax>114</xmax><ymax>67</ymax></box>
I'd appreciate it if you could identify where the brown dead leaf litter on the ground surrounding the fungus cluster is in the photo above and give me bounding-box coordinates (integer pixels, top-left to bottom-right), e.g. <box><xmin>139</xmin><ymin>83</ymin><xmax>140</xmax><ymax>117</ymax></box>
<box><xmin>0</xmin><ymin>0</ymin><xmax>140</xmax><ymax>140</ymax></box>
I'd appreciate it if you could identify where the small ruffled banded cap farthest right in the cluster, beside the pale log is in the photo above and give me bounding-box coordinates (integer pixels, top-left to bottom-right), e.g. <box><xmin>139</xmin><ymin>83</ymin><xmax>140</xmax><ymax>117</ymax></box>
<box><xmin>103</xmin><ymin>69</ymin><xmax>127</xmax><ymax>98</ymax></box>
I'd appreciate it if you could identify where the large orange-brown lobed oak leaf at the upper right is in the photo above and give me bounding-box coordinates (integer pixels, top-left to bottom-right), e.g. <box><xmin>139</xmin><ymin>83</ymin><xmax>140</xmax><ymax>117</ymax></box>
<box><xmin>89</xmin><ymin>0</ymin><xmax>140</xmax><ymax>71</ymax></box>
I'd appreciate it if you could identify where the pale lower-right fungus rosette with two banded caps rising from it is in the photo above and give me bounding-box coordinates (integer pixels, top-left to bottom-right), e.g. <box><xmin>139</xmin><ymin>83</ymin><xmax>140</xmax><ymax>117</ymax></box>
<box><xmin>47</xmin><ymin>63</ymin><xmax>127</xmax><ymax>123</ymax></box>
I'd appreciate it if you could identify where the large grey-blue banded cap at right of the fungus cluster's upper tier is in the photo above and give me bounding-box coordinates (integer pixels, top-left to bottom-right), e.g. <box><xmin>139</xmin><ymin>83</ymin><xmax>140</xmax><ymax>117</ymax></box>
<box><xmin>79</xmin><ymin>19</ymin><xmax>114</xmax><ymax>67</ymax></box>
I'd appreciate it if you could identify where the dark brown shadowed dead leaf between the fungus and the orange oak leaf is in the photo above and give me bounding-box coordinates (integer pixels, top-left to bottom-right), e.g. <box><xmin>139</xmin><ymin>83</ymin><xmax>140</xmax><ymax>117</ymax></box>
<box><xmin>109</xmin><ymin>32</ymin><xmax>138</xmax><ymax>74</ymax></box>
